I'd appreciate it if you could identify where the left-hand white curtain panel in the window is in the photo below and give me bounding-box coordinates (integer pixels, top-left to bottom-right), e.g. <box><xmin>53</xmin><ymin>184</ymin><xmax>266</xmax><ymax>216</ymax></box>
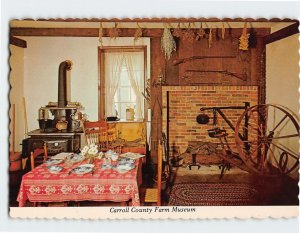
<box><xmin>105</xmin><ymin>53</ymin><xmax>124</xmax><ymax>116</ymax></box>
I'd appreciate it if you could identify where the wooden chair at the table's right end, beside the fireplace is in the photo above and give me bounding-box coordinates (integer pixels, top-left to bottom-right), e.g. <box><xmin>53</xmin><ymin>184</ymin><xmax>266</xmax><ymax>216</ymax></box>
<box><xmin>145</xmin><ymin>141</ymin><xmax>162</xmax><ymax>206</ymax></box>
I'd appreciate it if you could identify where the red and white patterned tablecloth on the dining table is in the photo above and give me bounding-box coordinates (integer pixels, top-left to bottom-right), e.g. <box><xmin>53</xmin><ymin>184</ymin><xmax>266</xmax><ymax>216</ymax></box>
<box><xmin>17</xmin><ymin>159</ymin><xmax>142</xmax><ymax>207</ymax></box>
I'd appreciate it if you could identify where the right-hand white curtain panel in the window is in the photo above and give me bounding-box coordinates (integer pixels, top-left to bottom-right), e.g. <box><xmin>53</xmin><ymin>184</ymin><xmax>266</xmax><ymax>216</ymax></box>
<box><xmin>124</xmin><ymin>52</ymin><xmax>144</xmax><ymax>120</ymax></box>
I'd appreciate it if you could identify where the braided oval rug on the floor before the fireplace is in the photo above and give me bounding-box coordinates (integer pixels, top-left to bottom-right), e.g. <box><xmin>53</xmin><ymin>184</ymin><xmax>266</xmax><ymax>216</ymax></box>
<box><xmin>169</xmin><ymin>183</ymin><xmax>258</xmax><ymax>206</ymax></box>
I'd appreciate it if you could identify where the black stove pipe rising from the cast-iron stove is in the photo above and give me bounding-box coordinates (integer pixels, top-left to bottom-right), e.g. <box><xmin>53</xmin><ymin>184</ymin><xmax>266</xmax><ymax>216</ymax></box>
<box><xmin>58</xmin><ymin>60</ymin><xmax>72</xmax><ymax>108</ymax></box>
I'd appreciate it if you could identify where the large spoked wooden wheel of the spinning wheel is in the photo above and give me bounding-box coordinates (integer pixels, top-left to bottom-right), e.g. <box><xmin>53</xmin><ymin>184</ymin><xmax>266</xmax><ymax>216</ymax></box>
<box><xmin>235</xmin><ymin>104</ymin><xmax>299</xmax><ymax>176</ymax></box>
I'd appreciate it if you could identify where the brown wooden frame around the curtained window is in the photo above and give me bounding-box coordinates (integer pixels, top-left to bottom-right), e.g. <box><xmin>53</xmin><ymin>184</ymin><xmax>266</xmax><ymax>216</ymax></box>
<box><xmin>98</xmin><ymin>45</ymin><xmax>147</xmax><ymax>122</ymax></box>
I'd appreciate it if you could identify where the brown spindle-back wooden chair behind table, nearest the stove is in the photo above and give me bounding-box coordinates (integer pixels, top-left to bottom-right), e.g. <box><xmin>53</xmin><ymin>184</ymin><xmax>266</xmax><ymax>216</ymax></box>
<box><xmin>83</xmin><ymin>121</ymin><xmax>108</xmax><ymax>150</ymax></box>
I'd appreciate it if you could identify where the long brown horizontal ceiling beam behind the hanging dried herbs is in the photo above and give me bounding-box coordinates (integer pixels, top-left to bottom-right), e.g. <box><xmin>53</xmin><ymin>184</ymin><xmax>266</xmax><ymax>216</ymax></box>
<box><xmin>10</xmin><ymin>28</ymin><xmax>270</xmax><ymax>37</ymax></box>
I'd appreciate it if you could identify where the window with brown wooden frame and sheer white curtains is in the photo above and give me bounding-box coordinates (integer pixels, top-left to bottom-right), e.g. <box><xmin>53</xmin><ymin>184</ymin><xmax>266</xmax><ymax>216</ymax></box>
<box><xmin>99</xmin><ymin>46</ymin><xmax>146</xmax><ymax>121</ymax></box>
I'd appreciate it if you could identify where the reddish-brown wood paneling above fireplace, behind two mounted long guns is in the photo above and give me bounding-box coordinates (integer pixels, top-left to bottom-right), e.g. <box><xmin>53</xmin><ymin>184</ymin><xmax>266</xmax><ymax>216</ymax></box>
<box><xmin>167</xmin><ymin>29</ymin><xmax>267</xmax><ymax>85</ymax></box>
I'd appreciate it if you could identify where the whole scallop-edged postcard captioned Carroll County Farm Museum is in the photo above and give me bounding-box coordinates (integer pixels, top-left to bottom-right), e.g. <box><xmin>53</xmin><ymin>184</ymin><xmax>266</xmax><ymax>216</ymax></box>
<box><xmin>9</xmin><ymin>16</ymin><xmax>299</xmax><ymax>219</ymax></box>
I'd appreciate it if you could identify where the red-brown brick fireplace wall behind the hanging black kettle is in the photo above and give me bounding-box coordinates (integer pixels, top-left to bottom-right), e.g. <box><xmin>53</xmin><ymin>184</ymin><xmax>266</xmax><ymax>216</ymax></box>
<box><xmin>162</xmin><ymin>85</ymin><xmax>258</xmax><ymax>153</ymax></box>
